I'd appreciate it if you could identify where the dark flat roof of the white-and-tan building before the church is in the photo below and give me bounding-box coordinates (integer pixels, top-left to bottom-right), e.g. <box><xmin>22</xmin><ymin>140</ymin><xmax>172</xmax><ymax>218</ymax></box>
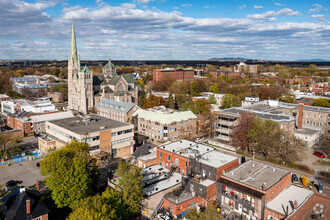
<box><xmin>51</xmin><ymin>115</ymin><xmax>133</xmax><ymax>135</ymax></box>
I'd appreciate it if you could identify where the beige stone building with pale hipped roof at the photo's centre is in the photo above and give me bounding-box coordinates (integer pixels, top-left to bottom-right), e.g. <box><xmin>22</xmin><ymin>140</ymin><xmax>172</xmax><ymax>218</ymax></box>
<box><xmin>133</xmin><ymin>106</ymin><xmax>197</xmax><ymax>141</ymax></box>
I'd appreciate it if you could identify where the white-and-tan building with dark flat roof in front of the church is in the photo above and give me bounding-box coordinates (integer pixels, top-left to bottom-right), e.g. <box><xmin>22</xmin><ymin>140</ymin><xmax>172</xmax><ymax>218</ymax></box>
<box><xmin>38</xmin><ymin>115</ymin><xmax>134</xmax><ymax>157</ymax></box>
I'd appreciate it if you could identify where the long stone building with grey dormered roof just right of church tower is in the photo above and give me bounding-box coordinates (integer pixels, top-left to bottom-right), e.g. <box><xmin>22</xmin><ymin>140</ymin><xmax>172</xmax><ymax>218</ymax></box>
<box><xmin>95</xmin><ymin>98</ymin><xmax>140</xmax><ymax>122</ymax></box>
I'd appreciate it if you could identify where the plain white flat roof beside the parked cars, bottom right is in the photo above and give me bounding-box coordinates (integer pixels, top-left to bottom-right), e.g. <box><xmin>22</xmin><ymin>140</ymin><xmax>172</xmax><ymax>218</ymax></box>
<box><xmin>267</xmin><ymin>185</ymin><xmax>313</xmax><ymax>215</ymax></box>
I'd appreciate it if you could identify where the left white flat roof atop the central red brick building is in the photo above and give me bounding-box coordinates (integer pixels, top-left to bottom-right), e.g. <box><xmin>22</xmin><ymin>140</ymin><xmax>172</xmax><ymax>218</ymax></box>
<box><xmin>158</xmin><ymin>140</ymin><xmax>214</xmax><ymax>157</ymax></box>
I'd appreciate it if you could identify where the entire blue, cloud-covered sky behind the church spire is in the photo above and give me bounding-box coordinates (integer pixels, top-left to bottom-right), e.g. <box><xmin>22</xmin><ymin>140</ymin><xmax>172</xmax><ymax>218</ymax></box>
<box><xmin>0</xmin><ymin>0</ymin><xmax>330</xmax><ymax>60</ymax></box>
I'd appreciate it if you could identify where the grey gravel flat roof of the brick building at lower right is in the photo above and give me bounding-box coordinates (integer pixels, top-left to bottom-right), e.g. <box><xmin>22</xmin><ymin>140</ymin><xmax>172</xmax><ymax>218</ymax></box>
<box><xmin>224</xmin><ymin>160</ymin><xmax>290</xmax><ymax>190</ymax></box>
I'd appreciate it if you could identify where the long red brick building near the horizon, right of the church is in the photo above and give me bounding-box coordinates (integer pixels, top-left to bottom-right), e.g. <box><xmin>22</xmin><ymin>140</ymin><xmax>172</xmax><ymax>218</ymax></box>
<box><xmin>152</xmin><ymin>68</ymin><xmax>194</xmax><ymax>82</ymax></box>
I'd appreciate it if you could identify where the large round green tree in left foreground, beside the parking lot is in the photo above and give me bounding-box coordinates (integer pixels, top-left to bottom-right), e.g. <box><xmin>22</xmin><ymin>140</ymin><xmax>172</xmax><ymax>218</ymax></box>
<box><xmin>40</xmin><ymin>140</ymin><xmax>98</xmax><ymax>208</ymax></box>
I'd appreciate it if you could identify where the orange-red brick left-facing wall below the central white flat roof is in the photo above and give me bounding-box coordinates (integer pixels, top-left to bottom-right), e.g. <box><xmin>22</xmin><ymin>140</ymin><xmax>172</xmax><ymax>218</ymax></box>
<box><xmin>156</xmin><ymin>148</ymin><xmax>189</xmax><ymax>174</ymax></box>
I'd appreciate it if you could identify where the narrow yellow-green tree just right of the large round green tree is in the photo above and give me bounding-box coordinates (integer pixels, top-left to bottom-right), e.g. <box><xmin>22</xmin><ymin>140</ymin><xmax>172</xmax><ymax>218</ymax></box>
<box><xmin>115</xmin><ymin>161</ymin><xmax>143</xmax><ymax>215</ymax></box>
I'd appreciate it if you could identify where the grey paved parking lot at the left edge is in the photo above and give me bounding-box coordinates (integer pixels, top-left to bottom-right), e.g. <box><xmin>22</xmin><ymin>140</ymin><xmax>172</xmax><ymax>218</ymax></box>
<box><xmin>0</xmin><ymin>159</ymin><xmax>44</xmax><ymax>187</ymax></box>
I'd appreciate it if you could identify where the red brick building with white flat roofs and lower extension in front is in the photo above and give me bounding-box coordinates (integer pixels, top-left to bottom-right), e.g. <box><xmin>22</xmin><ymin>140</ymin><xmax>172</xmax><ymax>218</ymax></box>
<box><xmin>150</xmin><ymin>140</ymin><xmax>239</xmax><ymax>217</ymax></box>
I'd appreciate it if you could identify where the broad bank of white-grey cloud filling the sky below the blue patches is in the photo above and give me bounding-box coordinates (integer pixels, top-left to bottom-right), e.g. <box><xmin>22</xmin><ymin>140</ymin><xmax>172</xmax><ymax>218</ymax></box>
<box><xmin>0</xmin><ymin>0</ymin><xmax>330</xmax><ymax>60</ymax></box>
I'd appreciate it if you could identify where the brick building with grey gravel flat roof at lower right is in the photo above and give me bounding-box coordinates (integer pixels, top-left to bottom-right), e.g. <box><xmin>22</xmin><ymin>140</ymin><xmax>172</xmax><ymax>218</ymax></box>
<box><xmin>217</xmin><ymin>160</ymin><xmax>291</xmax><ymax>220</ymax></box>
